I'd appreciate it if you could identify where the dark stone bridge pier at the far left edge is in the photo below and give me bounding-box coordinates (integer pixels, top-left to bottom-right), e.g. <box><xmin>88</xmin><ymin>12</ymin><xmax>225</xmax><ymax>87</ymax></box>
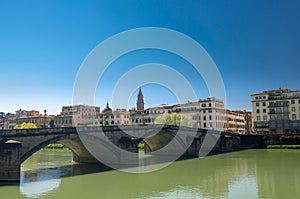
<box><xmin>0</xmin><ymin>140</ymin><xmax>22</xmax><ymax>182</ymax></box>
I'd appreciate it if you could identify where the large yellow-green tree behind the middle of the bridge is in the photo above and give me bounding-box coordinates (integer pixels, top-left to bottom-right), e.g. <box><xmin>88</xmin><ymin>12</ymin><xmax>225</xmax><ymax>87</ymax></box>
<box><xmin>154</xmin><ymin>113</ymin><xmax>195</xmax><ymax>127</ymax></box>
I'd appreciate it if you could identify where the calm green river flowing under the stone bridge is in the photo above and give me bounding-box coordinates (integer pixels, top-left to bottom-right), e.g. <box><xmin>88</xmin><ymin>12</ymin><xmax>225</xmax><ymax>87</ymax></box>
<box><xmin>0</xmin><ymin>149</ymin><xmax>300</xmax><ymax>199</ymax></box>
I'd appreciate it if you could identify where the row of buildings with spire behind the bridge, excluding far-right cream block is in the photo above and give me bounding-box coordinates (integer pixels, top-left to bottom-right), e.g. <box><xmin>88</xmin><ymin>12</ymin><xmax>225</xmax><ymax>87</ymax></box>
<box><xmin>0</xmin><ymin>89</ymin><xmax>252</xmax><ymax>134</ymax></box>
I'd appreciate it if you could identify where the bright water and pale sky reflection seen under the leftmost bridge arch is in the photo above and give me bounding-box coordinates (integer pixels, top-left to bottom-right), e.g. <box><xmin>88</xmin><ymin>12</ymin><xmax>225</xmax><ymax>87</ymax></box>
<box><xmin>20</xmin><ymin>149</ymin><xmax>72</xmax><ymax>198</ymax></box>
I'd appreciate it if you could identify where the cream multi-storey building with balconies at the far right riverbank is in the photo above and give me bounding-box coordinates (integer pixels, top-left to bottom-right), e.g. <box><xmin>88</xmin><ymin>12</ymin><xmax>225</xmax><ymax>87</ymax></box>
<box><xmin>251</xmin><ymin>89</ymin><xmax>300</xmax><ymax>134</ymax></box>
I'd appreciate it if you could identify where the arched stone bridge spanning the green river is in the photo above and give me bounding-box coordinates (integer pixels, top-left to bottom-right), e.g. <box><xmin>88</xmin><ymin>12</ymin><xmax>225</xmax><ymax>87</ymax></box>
<box><xmin>0</xmin><ymin>125</ymin><xmax>251</xmax><ymax>181</ymax></box>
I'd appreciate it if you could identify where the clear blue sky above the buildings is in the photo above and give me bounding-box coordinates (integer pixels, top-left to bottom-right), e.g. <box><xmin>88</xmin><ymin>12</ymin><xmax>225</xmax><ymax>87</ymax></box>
<box><xmin>0</xmin><ymin>0</ymin><xmax>300</xmax><ymax>114</ymax></box>
